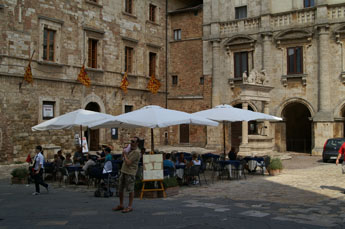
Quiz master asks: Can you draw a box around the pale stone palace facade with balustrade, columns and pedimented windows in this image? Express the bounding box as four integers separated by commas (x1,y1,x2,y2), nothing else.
203,0,345,154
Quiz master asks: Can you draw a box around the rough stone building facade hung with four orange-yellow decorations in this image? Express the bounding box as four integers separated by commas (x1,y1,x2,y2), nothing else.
0,0,166,162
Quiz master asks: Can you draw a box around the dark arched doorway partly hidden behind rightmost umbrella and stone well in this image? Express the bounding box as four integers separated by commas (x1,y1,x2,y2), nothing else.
230,103,257,150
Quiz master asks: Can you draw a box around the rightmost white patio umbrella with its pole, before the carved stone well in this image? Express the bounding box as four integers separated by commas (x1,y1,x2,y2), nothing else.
193,104,283,157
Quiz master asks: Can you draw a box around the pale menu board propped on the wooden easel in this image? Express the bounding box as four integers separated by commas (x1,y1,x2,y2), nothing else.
143,154,164,181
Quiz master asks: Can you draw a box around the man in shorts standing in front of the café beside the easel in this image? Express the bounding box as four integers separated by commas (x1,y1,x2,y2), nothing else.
112,137,140,213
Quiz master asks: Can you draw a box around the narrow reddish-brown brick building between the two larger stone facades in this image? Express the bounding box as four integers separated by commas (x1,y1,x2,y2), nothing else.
168,1,212,146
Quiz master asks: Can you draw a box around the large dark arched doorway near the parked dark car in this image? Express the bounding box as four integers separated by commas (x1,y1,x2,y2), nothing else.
282,102,312,153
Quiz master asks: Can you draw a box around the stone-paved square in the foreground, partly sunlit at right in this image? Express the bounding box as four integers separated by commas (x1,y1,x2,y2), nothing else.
0,155,345,229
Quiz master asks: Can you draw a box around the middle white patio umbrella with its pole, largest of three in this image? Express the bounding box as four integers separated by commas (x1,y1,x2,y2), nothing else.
89,105,218,151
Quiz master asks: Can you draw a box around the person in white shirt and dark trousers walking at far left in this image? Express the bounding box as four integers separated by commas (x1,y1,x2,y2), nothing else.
32,146,48,196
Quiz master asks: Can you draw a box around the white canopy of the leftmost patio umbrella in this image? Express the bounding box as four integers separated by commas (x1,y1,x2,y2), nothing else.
31,109,114,131
